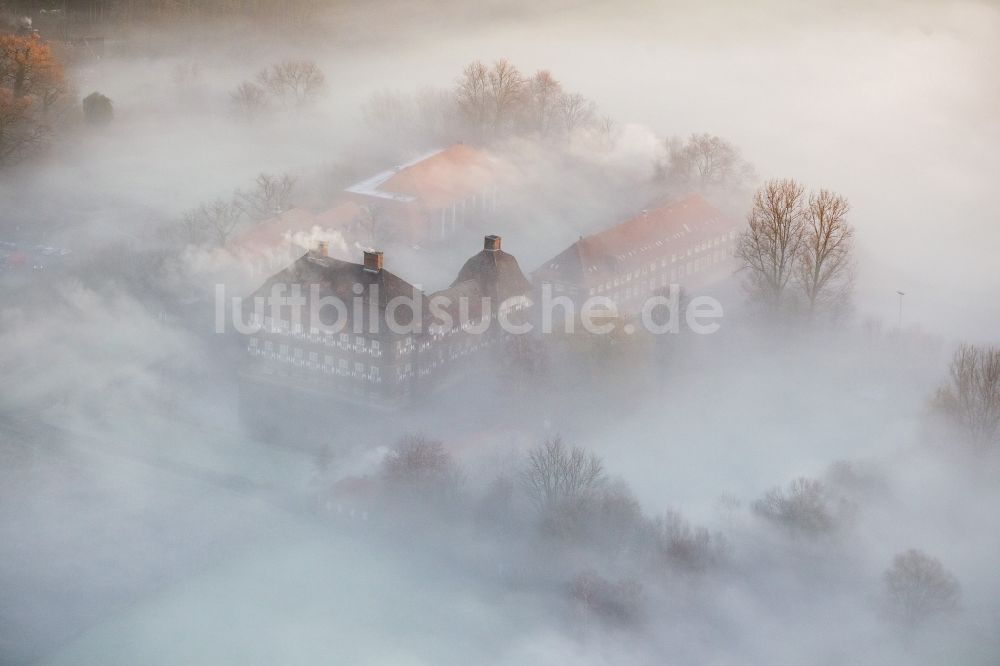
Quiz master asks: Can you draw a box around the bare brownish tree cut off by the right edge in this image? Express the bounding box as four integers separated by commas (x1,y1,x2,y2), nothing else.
934,345,1000,448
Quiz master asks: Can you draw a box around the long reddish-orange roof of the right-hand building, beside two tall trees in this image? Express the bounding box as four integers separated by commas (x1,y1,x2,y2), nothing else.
535,194,734,284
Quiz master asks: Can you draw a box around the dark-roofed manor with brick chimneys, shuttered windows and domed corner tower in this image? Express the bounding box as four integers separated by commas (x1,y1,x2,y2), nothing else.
243,236,531,407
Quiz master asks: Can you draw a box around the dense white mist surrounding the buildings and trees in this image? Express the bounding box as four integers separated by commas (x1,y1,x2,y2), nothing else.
0,1,1000,665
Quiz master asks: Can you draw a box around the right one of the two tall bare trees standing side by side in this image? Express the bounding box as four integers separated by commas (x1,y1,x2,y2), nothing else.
795,190,854,313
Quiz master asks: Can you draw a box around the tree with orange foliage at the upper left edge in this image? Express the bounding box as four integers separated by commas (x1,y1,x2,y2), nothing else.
0,34,66,166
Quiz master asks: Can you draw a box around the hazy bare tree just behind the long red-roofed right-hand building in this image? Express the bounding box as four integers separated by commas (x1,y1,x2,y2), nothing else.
660,134,753,189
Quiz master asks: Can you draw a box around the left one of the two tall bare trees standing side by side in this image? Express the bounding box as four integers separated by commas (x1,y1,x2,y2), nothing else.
736,179,805,307
